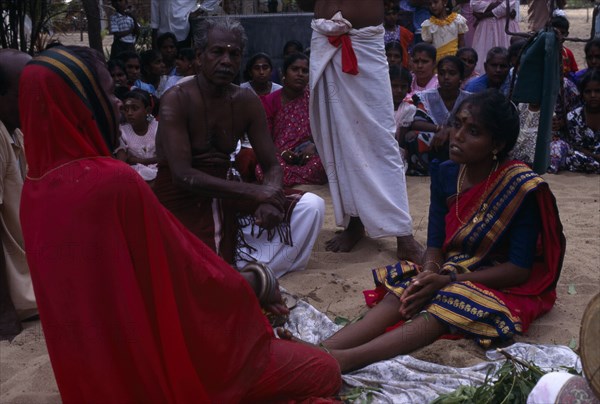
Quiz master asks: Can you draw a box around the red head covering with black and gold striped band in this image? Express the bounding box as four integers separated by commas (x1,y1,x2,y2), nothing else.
19,47,116,178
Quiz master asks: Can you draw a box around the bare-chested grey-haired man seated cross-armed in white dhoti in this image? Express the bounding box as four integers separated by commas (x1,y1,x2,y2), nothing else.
154,18,324,276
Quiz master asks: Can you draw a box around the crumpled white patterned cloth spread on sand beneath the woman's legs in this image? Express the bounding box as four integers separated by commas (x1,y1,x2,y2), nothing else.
285,300,581,404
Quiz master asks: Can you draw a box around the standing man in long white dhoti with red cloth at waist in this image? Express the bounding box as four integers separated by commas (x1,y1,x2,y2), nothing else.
298,0,422,262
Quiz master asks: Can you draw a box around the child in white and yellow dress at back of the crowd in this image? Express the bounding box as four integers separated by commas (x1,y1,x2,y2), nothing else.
421,0,469,60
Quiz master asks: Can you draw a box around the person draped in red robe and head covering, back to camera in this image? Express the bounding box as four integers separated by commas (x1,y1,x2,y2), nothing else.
19,47,341,403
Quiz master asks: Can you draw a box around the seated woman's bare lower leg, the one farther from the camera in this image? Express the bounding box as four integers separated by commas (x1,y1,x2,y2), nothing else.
323,293,402,350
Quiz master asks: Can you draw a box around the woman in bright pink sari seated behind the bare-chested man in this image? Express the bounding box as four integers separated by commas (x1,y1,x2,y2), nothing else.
256,53,327,187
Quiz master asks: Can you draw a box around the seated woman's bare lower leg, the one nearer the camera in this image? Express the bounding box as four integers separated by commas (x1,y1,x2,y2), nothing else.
330,314,448,373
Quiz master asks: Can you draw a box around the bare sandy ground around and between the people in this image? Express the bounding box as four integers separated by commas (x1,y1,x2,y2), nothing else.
0,6,600,404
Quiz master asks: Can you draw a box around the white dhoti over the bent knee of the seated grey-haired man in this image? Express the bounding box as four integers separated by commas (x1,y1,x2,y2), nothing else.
236,192,325,278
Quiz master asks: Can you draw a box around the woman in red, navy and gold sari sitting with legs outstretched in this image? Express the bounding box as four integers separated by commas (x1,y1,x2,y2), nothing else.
322,90,565,372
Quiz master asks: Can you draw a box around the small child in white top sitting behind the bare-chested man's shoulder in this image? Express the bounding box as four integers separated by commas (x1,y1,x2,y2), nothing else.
114,89,158,181
